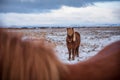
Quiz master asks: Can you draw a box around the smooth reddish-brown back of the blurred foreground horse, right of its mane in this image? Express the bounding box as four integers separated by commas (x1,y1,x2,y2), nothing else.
61,41,120,80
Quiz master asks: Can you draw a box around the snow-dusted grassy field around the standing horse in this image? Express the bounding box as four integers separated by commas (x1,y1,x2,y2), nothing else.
9,27,120,64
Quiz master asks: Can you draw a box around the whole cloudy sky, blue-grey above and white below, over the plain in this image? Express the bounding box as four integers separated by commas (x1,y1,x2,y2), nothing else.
0,0,120,26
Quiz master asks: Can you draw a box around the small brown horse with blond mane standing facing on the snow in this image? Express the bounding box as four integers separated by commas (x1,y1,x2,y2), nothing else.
66,28,80,60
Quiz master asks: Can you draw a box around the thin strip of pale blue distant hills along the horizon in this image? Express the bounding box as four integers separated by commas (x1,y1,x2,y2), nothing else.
0,24,120,29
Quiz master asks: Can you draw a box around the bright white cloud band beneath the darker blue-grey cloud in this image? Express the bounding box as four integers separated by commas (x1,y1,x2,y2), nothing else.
0,2,120,26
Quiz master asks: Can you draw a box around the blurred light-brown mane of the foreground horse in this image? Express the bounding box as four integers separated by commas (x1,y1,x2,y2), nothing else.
0,29,67,80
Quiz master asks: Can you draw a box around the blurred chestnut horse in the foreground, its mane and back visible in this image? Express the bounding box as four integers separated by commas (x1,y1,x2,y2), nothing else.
0,29,120,80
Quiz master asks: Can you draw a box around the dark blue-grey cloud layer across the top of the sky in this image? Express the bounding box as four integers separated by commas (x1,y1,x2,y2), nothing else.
0,0,119,13
